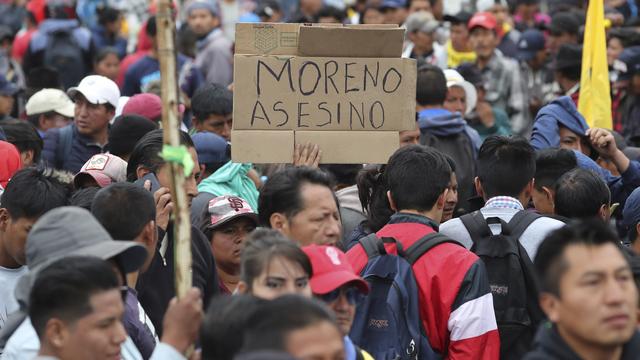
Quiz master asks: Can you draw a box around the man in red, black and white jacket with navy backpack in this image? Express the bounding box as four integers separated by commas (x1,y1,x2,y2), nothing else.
347,145,500,359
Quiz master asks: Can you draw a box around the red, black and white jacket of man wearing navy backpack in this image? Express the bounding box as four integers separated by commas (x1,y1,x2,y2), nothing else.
347,213,500,359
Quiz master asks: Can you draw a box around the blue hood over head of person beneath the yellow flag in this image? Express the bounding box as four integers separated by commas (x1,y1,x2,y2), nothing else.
531,96,589,150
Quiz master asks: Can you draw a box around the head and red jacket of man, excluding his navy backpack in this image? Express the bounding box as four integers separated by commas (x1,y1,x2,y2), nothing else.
347,145,500,359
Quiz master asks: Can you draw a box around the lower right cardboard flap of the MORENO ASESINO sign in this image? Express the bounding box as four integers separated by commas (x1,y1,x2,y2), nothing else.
296,131,400,164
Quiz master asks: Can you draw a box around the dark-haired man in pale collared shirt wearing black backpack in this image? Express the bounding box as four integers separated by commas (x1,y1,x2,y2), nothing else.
440,136,564,359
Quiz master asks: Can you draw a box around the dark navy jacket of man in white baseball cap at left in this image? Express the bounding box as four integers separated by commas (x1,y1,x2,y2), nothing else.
42,124,106,174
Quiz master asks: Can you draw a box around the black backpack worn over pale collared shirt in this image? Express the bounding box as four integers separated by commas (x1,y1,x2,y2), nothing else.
460,211,544,359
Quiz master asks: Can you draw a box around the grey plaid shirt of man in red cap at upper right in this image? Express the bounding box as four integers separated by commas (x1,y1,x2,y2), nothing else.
482,49,527,134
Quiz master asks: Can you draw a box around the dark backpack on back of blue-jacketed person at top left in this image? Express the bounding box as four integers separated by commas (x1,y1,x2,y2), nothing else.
44,29,88,89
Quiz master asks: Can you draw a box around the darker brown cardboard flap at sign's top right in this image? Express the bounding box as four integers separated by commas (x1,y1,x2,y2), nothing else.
298,26,404,58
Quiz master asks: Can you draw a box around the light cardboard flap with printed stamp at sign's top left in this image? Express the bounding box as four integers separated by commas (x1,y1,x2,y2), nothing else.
235,23,300,55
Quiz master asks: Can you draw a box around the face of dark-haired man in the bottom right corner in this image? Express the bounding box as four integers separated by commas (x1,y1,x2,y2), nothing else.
541,244,638,349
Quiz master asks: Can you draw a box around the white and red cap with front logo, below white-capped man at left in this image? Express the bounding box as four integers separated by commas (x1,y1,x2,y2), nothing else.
73,154,127,188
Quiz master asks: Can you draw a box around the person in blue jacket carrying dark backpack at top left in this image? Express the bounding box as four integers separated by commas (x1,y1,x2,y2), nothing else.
22,0,95,89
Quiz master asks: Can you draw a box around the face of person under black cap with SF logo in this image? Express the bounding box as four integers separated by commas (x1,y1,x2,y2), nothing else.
210,217,256,273
